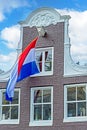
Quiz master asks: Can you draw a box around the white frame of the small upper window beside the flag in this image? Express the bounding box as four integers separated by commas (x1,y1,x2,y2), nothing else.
32,47,54,77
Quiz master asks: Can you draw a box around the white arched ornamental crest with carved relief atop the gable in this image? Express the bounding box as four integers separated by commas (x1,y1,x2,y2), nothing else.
20,7,70,27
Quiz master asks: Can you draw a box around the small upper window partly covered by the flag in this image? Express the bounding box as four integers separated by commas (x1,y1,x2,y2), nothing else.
36,47,53,75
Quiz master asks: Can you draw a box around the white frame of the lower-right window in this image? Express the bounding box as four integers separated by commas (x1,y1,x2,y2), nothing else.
63,83,87,122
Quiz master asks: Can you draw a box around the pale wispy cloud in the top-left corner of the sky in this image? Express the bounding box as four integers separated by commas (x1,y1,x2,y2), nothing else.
0,0,30,22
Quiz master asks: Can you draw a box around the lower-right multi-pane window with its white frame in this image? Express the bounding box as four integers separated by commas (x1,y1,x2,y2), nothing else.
64,84,87,122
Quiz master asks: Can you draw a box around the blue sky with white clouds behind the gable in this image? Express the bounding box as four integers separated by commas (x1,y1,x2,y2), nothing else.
0,0,87,71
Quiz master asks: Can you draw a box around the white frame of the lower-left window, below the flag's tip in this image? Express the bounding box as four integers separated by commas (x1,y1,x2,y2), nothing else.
0,89,20,124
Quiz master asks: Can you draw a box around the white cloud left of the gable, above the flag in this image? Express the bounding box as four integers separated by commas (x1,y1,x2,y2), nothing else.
0,25,20,71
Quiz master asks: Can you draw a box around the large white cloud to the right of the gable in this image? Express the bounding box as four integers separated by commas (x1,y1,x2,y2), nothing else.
58,9,87,65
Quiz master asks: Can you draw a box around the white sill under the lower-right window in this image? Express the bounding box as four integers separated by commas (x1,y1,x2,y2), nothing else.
63,116,87,122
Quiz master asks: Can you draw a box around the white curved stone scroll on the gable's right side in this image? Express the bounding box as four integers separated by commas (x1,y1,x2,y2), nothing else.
64,44,87,77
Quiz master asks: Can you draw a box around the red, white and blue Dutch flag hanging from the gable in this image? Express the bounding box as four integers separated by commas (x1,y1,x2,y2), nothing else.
6,38,39,101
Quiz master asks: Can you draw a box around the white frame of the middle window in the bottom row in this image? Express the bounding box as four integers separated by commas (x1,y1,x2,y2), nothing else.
29,86,53,126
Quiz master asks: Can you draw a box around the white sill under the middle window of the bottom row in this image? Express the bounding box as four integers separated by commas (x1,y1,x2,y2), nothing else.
29,121,53,126
